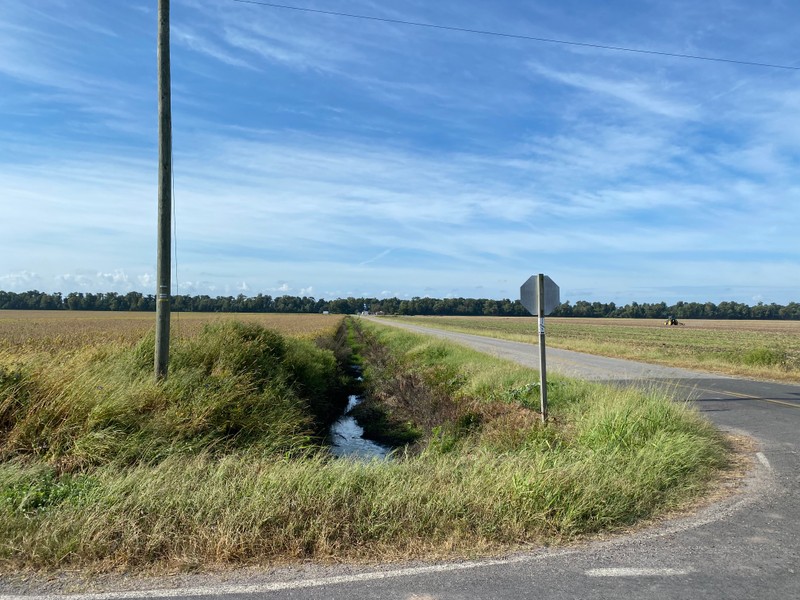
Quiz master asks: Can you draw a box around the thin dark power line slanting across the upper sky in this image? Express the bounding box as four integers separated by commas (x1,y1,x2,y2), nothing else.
232,0,800,71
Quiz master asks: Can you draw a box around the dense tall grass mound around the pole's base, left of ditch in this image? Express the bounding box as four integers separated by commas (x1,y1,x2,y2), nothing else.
0,322,343,471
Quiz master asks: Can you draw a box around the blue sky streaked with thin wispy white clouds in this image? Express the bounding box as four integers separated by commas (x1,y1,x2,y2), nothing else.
0,0,800,304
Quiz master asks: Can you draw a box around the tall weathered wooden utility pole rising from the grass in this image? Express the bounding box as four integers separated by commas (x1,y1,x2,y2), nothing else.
155,0,172,379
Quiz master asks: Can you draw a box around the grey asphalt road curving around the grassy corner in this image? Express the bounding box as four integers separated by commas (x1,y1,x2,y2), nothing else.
0,322,800,600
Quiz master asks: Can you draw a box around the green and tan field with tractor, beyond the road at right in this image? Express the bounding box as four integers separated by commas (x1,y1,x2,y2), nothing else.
390,316,800,381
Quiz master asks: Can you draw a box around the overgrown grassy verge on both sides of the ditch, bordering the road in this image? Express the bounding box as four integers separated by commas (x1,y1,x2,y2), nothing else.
0,324,725,571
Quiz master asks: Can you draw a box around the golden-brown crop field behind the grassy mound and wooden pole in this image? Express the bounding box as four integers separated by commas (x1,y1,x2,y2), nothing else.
0,310,342,351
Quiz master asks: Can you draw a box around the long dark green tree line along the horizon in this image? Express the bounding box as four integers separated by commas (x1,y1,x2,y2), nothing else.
0,290,800,320
